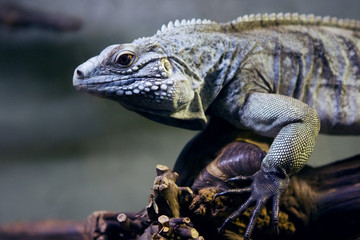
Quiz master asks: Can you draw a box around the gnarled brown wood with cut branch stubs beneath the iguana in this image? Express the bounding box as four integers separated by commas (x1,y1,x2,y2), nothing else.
0,141,360,240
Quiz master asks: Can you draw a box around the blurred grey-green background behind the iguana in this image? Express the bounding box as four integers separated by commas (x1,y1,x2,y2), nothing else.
0,0,360,224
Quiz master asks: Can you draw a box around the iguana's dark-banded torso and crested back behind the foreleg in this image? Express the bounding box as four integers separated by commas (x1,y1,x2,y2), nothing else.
211,19,360,134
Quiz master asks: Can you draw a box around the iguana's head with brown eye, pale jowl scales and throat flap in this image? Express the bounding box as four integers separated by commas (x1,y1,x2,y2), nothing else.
73,34,206,129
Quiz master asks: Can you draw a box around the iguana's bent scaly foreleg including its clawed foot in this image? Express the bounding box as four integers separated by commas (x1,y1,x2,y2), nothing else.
216,93,320,239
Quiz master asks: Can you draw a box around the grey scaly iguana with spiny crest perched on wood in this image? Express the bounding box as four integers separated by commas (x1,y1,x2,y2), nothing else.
73,13,360,239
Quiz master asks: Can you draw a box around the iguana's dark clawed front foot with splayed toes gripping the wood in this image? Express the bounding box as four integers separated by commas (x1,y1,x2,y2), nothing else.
215,169,289,240
